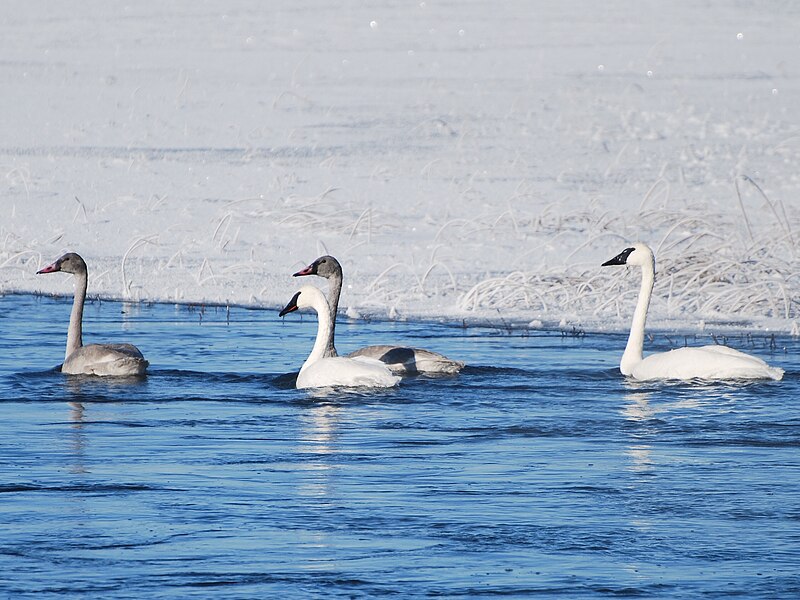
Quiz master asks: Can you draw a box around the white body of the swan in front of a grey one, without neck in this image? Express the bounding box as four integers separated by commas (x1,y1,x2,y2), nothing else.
297,356,400,389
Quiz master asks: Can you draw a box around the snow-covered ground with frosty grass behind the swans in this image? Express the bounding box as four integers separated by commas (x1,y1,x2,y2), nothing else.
0,0,800,332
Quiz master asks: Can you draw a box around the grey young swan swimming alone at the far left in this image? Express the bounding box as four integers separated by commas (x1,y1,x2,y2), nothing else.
36,252,149,375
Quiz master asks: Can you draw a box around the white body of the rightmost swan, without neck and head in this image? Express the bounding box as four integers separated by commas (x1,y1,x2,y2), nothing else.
626,346,783,380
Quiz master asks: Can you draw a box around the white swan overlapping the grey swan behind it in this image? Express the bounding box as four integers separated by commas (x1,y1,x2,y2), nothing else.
279,285,400,389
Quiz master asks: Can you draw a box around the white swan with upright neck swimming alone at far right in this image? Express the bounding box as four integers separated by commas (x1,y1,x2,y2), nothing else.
602,243,783,380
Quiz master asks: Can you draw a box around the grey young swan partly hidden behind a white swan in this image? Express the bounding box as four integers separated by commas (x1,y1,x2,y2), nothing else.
293,255,464,375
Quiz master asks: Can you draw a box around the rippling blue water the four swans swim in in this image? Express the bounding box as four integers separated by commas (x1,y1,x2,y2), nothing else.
0,296,800,598
